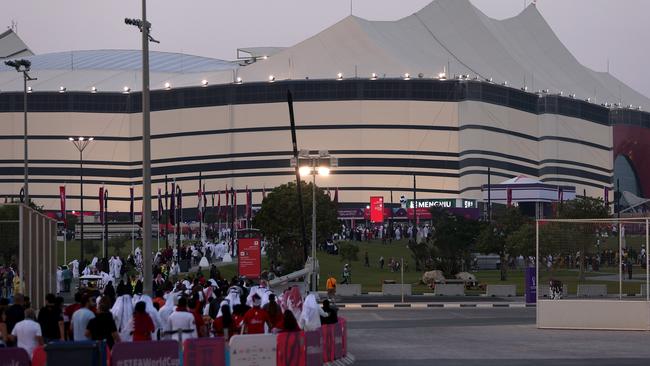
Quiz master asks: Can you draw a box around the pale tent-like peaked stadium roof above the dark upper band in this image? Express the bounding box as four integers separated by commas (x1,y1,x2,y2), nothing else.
0,0,650,109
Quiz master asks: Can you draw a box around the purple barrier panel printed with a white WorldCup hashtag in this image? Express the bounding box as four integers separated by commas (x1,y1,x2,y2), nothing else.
111,341,180,366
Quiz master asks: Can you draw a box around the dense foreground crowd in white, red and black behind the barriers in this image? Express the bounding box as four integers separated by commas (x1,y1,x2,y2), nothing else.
0,260,337,355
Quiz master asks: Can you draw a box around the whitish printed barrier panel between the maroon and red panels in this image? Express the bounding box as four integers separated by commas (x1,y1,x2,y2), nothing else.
230,334,277,366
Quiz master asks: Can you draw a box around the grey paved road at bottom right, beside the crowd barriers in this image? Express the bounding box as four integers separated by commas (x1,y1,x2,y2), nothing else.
340,308,650,366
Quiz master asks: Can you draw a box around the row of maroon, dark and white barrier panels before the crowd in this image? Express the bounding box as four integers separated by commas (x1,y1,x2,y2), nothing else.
0,318,347,366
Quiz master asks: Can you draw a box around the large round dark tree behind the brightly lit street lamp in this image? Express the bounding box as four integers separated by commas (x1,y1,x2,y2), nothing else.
253,182,339,272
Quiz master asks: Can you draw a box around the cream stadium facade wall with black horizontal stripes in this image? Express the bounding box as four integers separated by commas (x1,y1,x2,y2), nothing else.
0,78,628,212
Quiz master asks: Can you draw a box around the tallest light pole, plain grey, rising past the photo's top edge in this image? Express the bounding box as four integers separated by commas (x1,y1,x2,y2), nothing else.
124,0,160,295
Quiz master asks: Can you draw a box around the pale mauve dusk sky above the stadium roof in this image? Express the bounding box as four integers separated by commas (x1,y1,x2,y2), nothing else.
5,0,650,96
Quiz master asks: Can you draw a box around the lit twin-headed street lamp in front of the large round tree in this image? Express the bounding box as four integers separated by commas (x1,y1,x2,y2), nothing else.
291,150,338,291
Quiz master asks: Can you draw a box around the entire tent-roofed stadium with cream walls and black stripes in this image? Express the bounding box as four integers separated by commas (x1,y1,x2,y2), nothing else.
0,0,650,217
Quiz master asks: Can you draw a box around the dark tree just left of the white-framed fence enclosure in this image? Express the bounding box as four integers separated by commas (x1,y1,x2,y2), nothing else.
476,206,535,281
